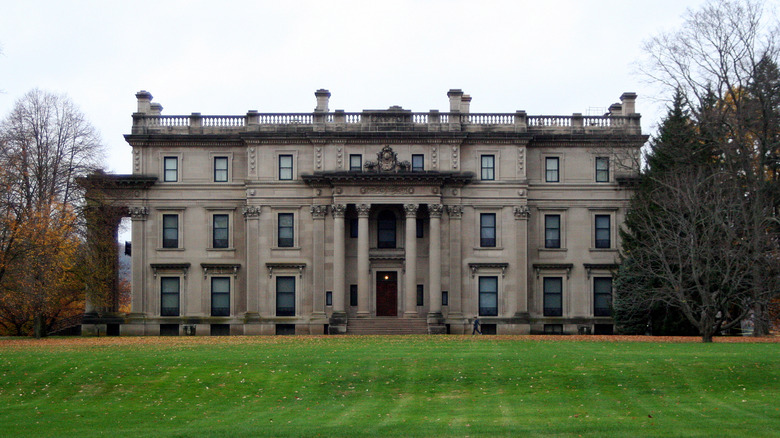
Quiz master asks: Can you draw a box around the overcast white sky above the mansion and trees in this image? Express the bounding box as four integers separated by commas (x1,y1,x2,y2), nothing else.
0,0,774,173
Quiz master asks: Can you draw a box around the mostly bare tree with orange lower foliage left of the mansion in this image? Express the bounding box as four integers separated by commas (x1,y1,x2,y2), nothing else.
0,89,103,333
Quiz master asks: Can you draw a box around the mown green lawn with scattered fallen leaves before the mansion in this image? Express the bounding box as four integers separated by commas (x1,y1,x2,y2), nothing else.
0,336,780,437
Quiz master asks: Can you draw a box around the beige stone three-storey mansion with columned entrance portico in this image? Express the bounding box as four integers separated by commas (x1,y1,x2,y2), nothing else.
109,90,646,335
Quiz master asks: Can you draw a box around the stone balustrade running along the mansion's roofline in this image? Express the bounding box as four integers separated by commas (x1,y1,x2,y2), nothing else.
132,110,641,134
